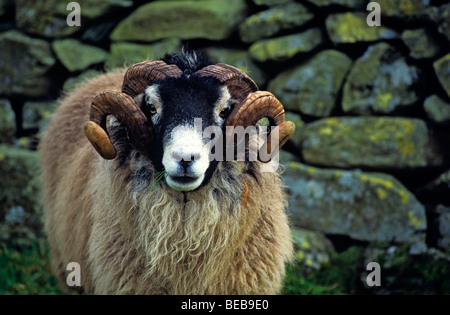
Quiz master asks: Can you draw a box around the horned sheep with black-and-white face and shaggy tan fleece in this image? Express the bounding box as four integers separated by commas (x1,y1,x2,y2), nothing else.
39,53,294,294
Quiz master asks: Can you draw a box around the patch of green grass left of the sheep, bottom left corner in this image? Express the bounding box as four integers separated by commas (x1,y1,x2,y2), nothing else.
0,240,63,294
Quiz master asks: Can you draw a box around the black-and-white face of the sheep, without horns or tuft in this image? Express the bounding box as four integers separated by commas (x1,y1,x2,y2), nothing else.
141,74,233,191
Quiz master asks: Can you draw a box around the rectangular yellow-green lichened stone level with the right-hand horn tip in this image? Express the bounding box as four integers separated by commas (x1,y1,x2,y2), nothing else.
302,117,431,169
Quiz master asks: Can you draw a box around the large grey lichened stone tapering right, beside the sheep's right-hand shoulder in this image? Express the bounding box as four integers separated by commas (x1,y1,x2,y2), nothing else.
284,162,427,243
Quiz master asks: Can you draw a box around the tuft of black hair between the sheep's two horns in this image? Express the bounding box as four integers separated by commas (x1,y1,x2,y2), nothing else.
162,49,214,74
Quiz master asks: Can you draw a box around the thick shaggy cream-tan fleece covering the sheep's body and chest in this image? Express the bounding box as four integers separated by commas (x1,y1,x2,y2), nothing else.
40,70,292,294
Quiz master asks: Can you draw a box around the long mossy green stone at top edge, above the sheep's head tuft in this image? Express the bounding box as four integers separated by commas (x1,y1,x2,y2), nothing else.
111,0,246,41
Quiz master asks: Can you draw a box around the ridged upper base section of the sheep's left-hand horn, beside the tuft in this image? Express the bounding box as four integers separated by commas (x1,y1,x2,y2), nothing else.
122,60,182,97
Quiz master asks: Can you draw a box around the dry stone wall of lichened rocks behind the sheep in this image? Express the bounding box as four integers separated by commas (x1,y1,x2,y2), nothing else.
0,0,450,292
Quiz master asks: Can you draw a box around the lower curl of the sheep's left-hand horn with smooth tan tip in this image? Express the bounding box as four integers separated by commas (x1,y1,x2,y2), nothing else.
84,91,153,159
